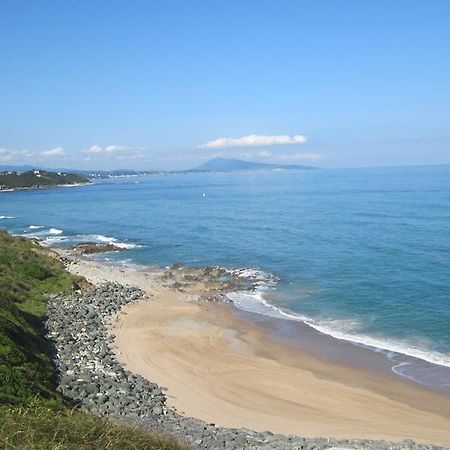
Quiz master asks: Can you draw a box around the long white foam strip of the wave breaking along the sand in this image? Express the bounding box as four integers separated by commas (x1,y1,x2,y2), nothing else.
227,289,450,373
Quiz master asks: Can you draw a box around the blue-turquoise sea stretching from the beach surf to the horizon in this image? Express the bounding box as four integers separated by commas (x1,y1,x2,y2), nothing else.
0,166,450,386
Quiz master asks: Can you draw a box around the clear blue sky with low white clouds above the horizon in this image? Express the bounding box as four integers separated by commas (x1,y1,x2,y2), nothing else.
0,0,450,169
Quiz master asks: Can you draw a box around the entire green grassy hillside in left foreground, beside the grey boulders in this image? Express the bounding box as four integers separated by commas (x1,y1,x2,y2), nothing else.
0,230,184,450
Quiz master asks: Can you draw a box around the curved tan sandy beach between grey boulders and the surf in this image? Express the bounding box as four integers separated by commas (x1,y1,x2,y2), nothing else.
61,252,450,446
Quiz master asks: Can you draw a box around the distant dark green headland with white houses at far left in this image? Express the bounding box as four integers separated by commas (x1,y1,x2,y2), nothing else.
0,170,89,190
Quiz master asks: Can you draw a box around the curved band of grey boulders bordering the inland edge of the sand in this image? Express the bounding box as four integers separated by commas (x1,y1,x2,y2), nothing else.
47,283,446,450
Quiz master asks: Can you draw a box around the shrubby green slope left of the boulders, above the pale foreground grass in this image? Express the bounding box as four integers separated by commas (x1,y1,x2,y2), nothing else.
0,231,80,405
